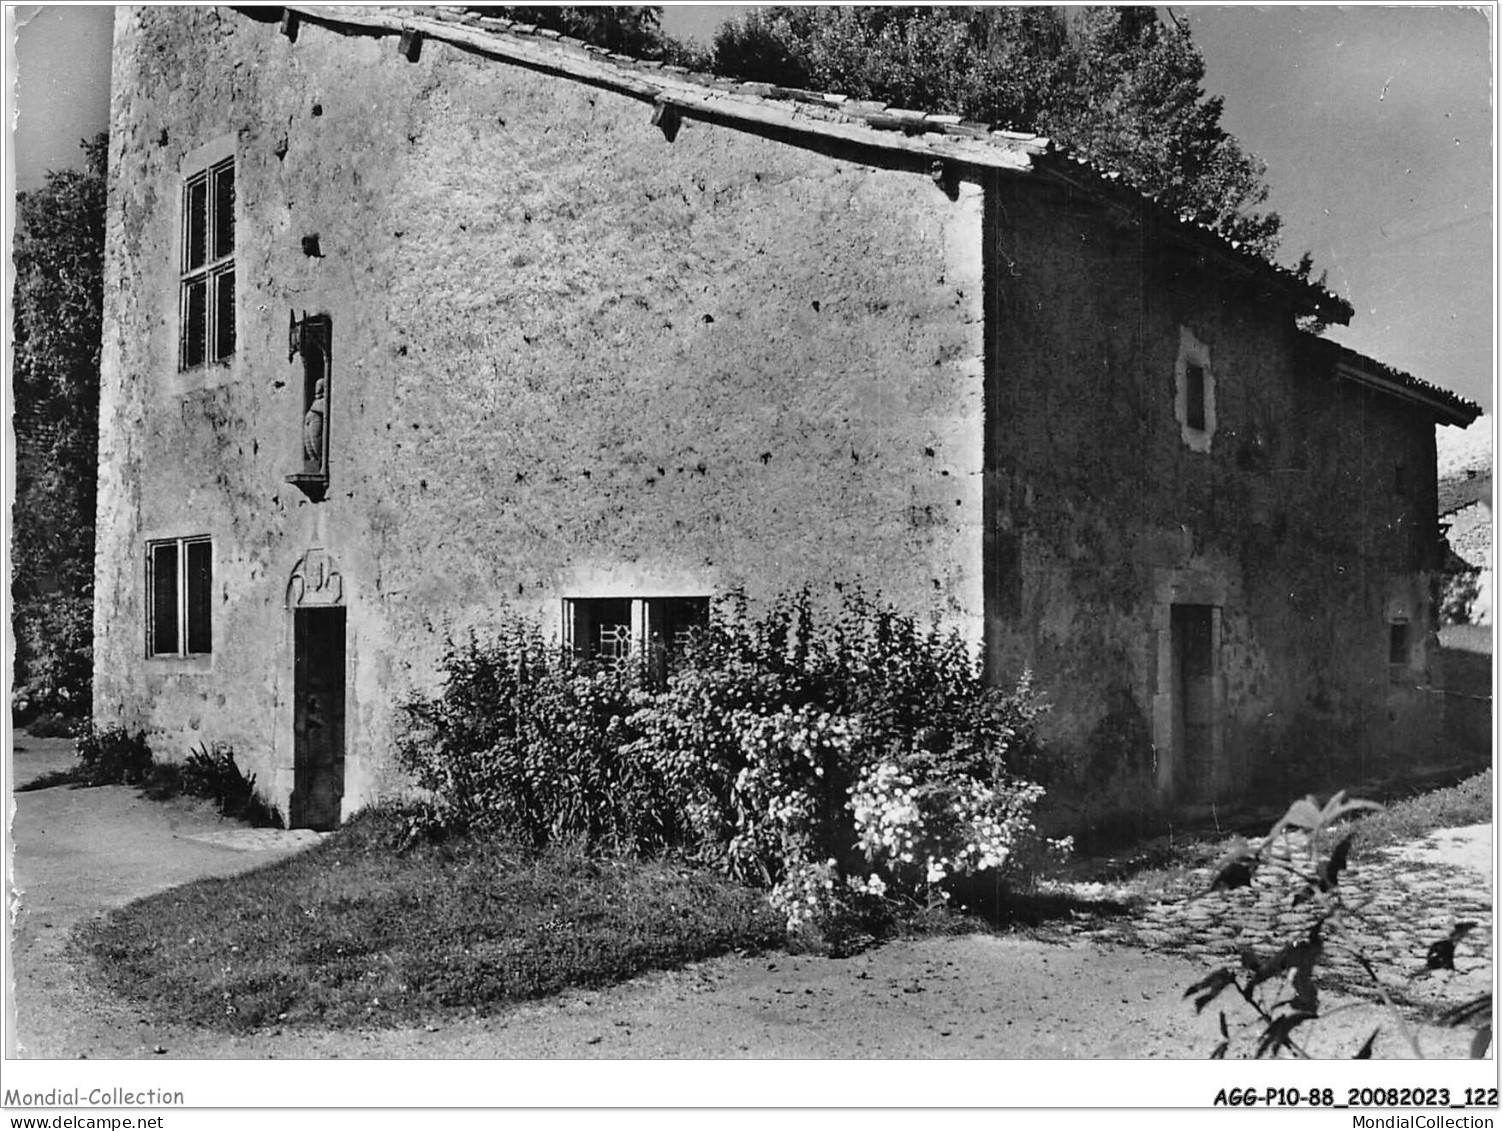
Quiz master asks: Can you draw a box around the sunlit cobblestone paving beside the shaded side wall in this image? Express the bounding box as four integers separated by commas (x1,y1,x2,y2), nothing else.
1060,841,1492,1005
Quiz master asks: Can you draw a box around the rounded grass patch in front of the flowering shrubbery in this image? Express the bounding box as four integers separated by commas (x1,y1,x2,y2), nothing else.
80,811,783,1030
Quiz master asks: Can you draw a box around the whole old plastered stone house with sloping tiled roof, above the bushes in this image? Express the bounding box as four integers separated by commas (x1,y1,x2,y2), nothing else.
95,8,1476,826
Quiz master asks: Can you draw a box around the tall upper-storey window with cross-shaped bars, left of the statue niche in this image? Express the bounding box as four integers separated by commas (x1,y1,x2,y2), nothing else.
177,158,234,368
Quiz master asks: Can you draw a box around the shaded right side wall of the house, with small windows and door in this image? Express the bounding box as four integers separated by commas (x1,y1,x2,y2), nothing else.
984,172,1438,829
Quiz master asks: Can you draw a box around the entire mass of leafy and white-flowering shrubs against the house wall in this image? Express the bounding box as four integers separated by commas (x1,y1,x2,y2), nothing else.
400,590,1049,929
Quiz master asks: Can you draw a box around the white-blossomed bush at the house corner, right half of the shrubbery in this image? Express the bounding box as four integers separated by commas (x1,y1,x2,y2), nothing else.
630,591,1064,929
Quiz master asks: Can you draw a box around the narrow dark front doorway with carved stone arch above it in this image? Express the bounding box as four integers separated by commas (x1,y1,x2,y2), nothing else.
287,549,346,832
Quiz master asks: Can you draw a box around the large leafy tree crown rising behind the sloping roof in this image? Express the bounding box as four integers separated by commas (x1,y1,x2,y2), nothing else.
714,6,1279,254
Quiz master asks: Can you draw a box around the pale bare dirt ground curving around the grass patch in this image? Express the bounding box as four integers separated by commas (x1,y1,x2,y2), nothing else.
6,735,1477,1060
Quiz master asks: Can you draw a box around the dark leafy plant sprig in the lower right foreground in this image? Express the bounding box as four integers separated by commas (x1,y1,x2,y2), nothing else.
1184,791,1492,1060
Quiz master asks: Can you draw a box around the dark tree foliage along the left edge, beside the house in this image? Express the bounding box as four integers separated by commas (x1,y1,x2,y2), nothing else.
11,134,108,710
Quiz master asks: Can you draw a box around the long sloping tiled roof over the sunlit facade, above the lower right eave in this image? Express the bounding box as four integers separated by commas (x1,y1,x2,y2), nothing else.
276,5,1353,323
